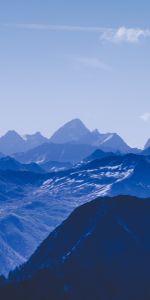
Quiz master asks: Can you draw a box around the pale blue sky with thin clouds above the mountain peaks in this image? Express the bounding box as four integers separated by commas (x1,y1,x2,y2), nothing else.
0,0,150,147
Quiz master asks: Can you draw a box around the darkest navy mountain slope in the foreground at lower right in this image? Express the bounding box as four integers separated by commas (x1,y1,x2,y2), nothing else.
0,196,150,300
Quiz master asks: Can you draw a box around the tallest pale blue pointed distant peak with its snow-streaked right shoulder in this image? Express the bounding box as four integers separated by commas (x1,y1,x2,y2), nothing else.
50,119,139,153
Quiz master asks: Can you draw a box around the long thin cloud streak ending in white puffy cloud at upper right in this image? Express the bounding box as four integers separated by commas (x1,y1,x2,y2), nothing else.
0,23,150,43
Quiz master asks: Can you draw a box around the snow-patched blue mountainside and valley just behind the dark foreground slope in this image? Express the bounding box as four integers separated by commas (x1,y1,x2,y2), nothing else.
0,154,150,275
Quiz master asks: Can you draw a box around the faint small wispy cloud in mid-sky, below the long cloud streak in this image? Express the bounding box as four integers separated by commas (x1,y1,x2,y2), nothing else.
73,57,111,71
